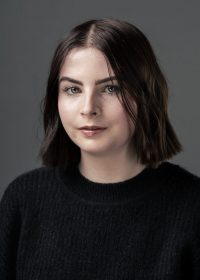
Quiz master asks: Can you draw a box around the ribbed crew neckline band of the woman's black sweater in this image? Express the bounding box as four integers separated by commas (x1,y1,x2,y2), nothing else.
57,162,170,204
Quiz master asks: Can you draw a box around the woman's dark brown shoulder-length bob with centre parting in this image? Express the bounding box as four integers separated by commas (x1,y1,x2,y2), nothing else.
38,18,183,168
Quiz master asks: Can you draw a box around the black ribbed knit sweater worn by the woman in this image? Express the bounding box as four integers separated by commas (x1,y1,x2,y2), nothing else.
0,162,200,280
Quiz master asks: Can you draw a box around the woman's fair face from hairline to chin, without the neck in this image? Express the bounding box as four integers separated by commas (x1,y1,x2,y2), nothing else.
58,48,137,159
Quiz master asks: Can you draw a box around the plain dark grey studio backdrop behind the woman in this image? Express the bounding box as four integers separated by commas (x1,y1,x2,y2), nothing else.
0,0,200,198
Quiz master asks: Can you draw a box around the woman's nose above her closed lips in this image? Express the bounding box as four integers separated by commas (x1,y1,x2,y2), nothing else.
81,94,101,116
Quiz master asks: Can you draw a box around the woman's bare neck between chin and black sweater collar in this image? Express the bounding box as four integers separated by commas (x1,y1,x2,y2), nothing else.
79,150,146,183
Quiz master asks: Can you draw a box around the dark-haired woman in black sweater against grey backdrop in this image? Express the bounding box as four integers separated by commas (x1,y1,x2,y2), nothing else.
0,19,200,280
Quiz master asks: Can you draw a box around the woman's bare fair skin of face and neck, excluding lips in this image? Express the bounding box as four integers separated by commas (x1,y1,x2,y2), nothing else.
58,48,145,183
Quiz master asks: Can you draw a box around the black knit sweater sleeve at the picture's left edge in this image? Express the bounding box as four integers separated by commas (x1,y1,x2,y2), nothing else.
0,182,20,280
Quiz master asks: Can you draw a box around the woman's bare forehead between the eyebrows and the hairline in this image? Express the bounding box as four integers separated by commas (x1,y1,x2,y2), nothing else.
60,47,114,76
